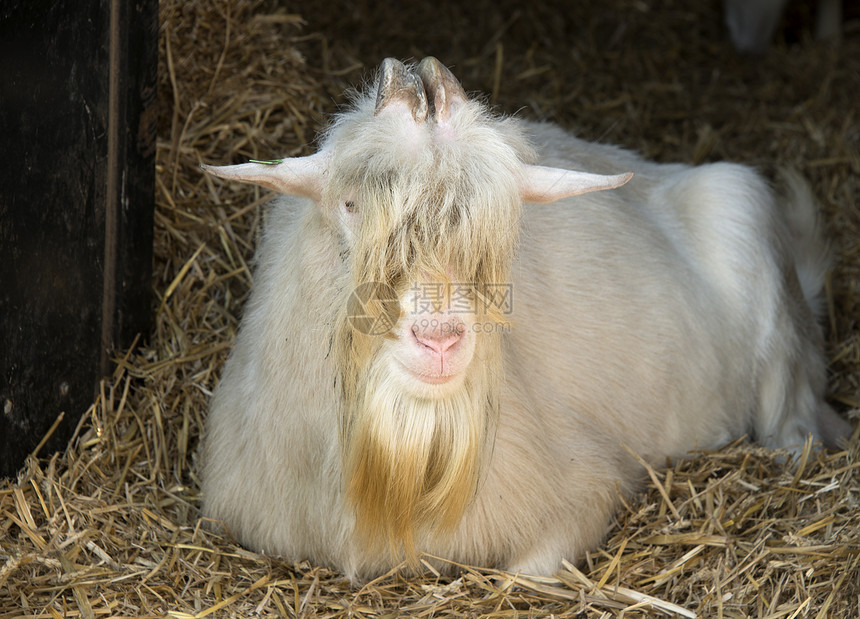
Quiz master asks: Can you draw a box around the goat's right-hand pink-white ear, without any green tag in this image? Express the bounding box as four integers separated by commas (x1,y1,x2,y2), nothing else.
520,165,633,203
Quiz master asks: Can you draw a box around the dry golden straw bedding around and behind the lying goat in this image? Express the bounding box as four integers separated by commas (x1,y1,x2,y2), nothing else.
0,0,860,619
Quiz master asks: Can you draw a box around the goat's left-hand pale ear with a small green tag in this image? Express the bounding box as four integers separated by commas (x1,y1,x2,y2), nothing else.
200,152,328,200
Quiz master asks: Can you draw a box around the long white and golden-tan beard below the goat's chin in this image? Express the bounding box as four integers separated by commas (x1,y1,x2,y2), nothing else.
342,346,499,566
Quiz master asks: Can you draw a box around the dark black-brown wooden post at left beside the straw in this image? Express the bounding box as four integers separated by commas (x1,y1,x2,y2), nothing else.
0,0,158,476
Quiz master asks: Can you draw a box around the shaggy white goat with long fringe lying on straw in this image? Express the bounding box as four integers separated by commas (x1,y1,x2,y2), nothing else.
202,58,850,579
